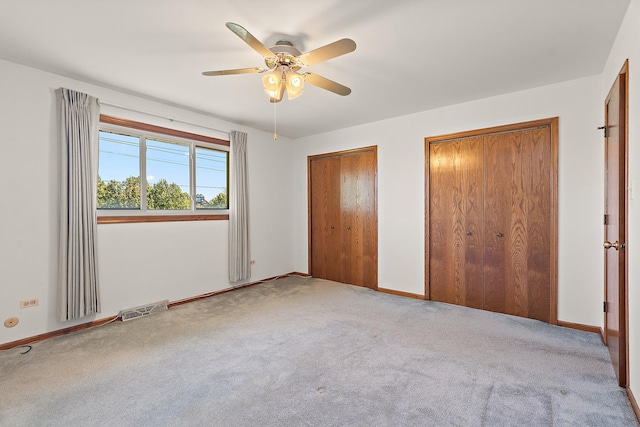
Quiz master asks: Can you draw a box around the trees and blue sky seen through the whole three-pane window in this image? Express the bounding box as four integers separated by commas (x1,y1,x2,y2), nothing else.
97,131,228,211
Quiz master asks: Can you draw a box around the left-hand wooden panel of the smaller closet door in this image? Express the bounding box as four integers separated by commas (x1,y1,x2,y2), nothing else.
309,156,342,281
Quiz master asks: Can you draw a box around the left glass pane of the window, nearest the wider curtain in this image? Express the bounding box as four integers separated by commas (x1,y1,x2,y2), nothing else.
97,132,140,209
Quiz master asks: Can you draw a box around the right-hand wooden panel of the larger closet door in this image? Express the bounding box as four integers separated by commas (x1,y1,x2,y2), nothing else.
484,127,553,322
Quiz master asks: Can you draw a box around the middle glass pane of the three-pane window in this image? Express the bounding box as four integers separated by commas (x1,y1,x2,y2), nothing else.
147,139,191,210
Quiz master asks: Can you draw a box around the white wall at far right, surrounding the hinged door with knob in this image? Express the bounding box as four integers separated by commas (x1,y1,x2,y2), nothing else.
600,0,640,399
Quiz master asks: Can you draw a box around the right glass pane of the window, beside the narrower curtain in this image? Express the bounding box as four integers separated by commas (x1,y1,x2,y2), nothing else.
196,147,229,209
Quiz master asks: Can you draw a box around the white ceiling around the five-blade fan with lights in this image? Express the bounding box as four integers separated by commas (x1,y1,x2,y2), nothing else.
0,0,629,138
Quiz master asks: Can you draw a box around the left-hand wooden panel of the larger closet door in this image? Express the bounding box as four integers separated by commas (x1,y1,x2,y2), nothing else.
429,137,483,308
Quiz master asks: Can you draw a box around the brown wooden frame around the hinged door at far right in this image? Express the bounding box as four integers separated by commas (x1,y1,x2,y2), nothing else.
602,59,629,388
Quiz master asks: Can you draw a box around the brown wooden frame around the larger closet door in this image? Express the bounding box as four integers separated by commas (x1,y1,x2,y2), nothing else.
424,117,558,325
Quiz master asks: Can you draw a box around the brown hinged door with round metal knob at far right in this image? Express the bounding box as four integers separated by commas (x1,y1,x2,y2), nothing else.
604,63,627,387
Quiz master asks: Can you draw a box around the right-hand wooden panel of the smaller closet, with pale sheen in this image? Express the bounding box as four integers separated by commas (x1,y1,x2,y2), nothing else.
340,150,378,289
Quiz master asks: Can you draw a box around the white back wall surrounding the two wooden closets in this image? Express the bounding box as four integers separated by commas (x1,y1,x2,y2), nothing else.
293,76,603,326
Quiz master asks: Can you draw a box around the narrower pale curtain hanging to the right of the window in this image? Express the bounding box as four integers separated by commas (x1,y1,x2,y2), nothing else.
229,130,251,283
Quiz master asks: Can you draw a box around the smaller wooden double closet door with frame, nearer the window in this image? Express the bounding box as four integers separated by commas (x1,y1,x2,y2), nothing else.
308,147,378,289
